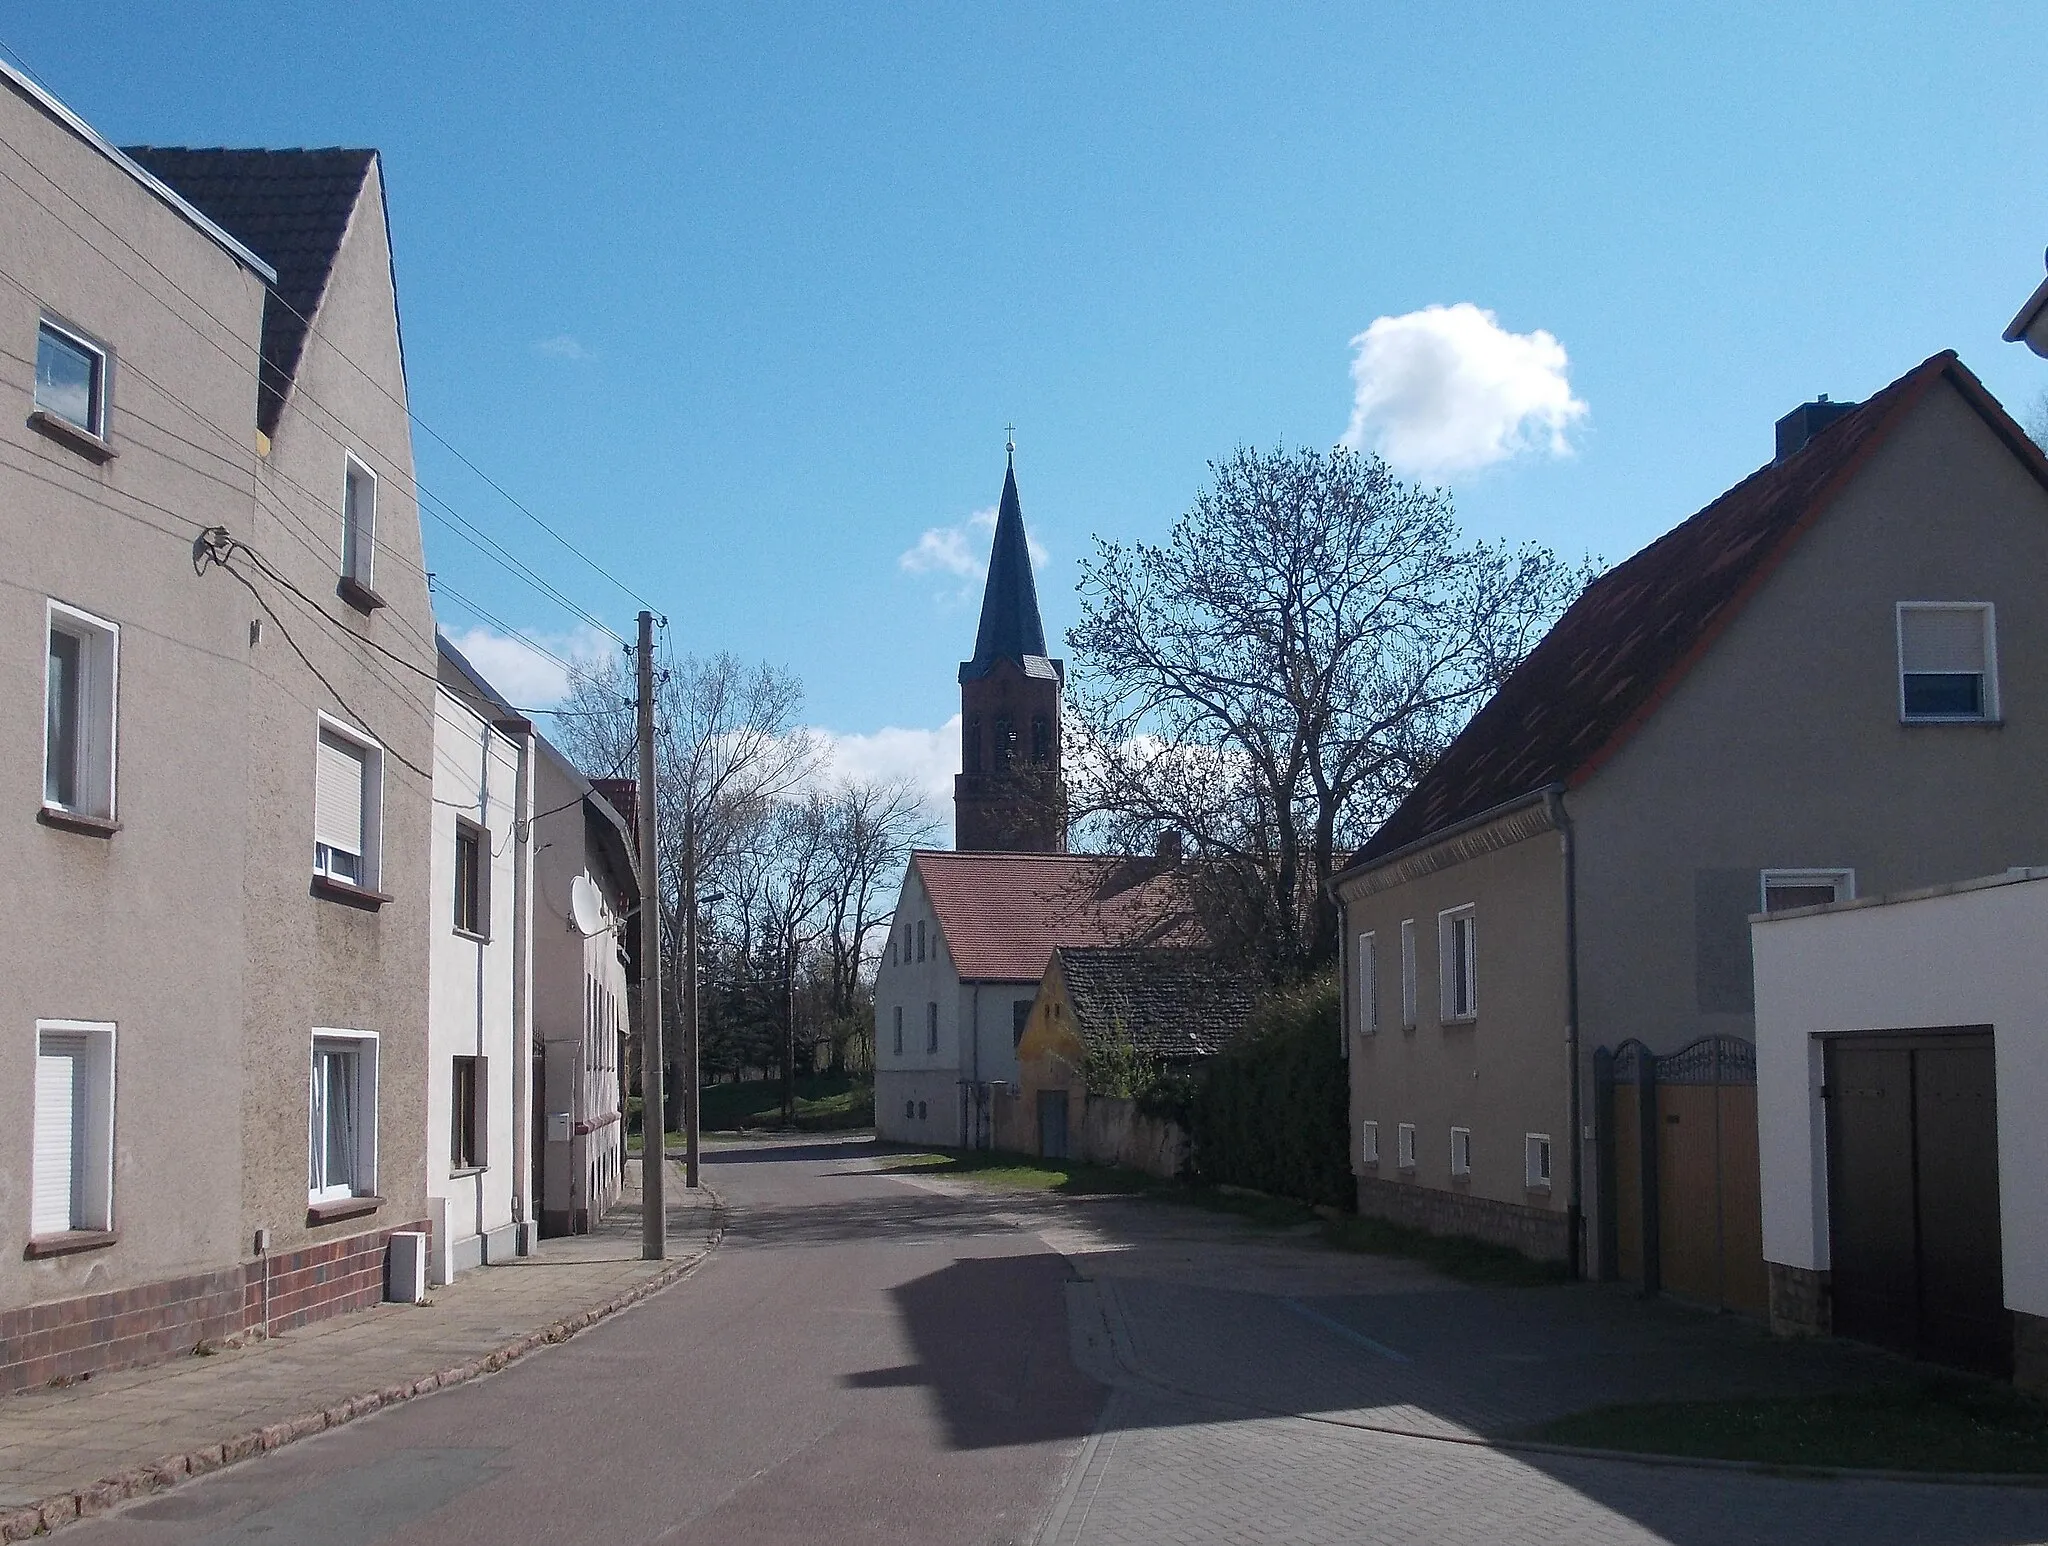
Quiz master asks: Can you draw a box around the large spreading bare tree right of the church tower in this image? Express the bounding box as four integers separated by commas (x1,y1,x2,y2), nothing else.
1067,446,1591,977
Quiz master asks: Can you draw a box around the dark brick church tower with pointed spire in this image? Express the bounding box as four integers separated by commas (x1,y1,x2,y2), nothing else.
952,444,1067,854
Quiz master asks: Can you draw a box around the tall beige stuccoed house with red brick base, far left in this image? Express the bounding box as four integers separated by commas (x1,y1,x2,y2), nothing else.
0,66,434,1388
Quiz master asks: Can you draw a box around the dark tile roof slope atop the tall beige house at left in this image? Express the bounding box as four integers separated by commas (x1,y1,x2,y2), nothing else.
125,145,377,434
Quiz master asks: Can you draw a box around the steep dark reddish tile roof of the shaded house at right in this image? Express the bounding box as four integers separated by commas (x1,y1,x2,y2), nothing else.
1350,350,2048,870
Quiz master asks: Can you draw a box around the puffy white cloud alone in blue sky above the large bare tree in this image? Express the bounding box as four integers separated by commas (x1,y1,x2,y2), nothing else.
1343,301,1587,475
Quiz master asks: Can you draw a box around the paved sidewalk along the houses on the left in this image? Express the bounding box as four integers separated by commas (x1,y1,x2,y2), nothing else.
0,1163,721,1540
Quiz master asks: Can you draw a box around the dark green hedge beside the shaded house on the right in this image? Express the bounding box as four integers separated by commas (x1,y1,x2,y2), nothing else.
1188,973,1358,1210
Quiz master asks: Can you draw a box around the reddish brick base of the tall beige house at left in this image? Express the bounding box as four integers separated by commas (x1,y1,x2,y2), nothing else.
0,1220,426,1394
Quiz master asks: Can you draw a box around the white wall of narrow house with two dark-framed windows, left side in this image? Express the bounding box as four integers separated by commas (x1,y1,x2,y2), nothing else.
426,690,524,1280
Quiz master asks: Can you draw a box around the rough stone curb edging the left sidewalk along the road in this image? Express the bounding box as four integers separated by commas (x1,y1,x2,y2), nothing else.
0,1186,725,1542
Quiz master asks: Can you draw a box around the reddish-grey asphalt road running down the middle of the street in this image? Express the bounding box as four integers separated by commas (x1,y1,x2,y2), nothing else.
63,1141,1106,1546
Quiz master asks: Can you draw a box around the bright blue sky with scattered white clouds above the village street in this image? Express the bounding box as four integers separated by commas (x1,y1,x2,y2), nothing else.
0,0,2048,823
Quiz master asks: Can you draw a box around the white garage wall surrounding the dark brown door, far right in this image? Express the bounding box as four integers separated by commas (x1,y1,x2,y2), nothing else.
1751,870,2048,1315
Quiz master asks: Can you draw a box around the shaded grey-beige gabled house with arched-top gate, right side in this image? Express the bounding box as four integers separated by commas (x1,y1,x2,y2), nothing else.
1333,354,2048,1315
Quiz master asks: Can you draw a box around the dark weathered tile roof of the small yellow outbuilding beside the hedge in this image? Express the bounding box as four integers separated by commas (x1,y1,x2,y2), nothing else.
1053,948,1251,1059
